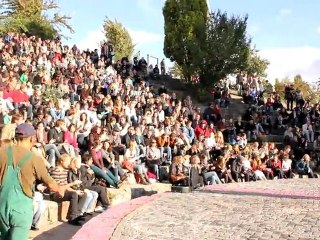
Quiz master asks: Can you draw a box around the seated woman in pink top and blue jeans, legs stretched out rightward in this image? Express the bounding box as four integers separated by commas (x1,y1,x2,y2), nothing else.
90,139,119,188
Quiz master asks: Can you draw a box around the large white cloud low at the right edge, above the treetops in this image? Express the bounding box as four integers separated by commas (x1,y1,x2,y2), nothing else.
259,46,320,83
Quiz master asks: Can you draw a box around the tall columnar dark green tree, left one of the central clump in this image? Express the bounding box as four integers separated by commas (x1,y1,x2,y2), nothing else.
163,0,208,81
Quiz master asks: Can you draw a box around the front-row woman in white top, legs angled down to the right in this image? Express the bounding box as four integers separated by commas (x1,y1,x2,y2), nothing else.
122,140,149,185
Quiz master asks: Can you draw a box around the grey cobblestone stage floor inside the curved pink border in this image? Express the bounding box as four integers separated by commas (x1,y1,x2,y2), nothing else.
112,179,320,240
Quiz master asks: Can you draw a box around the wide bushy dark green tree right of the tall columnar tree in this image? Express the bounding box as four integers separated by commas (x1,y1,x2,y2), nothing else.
199,11,250,87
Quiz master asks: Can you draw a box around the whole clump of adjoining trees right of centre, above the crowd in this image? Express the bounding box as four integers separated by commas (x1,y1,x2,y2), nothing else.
163,0,269,87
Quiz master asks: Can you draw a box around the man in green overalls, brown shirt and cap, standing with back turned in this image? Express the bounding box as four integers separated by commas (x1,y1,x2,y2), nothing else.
0,123,65,240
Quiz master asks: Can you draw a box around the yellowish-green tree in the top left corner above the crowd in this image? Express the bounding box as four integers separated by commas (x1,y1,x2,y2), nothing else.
0,0,74,38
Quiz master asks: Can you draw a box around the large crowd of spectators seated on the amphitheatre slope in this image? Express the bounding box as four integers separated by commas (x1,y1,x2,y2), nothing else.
0,33,320,238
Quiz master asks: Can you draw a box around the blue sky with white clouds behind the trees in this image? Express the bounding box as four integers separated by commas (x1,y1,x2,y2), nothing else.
58,0,320,82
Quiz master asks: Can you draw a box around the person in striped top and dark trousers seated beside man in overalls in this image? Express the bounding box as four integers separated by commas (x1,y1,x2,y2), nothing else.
50,154,82,226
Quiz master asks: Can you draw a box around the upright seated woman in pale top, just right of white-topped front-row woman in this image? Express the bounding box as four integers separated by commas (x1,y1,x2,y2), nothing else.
146,139,161,180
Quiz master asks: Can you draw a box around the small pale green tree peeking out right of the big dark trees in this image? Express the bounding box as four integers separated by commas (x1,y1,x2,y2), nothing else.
244,48,269,77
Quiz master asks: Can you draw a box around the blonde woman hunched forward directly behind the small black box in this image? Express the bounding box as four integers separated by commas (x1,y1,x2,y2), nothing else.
169,156,190,186
